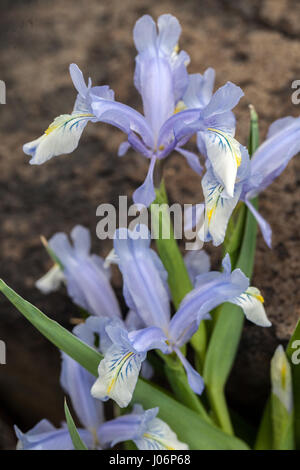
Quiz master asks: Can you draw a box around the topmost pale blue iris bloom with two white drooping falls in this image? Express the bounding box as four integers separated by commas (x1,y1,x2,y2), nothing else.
23,15,243,206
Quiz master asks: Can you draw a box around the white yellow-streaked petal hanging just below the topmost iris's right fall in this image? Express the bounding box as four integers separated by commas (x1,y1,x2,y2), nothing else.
199,170,242,246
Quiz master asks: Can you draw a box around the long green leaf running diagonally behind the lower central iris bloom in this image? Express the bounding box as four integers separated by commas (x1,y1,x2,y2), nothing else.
0,280,248,450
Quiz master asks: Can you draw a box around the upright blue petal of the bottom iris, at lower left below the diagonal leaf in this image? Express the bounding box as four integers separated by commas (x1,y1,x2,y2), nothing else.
60,353,104,433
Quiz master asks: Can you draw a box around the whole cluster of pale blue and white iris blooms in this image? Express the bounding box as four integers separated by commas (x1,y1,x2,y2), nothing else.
16,15,300,449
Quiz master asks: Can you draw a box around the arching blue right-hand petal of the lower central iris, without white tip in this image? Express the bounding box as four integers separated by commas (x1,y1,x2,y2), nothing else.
169,260,249,347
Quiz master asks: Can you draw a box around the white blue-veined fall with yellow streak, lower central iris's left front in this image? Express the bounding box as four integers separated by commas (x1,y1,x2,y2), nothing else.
91,344,146,408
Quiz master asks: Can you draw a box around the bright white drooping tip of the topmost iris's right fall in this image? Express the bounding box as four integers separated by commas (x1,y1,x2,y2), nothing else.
204,128,242,197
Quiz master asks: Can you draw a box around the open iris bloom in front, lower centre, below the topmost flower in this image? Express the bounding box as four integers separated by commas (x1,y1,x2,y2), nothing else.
92,226,270,406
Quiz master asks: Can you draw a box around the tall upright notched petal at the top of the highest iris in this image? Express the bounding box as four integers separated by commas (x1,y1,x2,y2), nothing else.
133,15,188,143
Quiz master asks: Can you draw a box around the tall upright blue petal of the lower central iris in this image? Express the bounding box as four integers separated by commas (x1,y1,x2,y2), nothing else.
114,225,170,331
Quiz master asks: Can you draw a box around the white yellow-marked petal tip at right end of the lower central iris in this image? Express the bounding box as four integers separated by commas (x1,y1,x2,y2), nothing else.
234,287,271,326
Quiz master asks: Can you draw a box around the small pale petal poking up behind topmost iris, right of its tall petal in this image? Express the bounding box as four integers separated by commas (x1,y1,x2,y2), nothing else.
182,68,215,109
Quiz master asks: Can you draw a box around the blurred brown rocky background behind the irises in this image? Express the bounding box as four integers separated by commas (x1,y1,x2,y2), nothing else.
0,0,300,448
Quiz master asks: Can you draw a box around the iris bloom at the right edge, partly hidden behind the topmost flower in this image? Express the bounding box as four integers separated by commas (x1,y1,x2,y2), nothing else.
186,117,300,248
